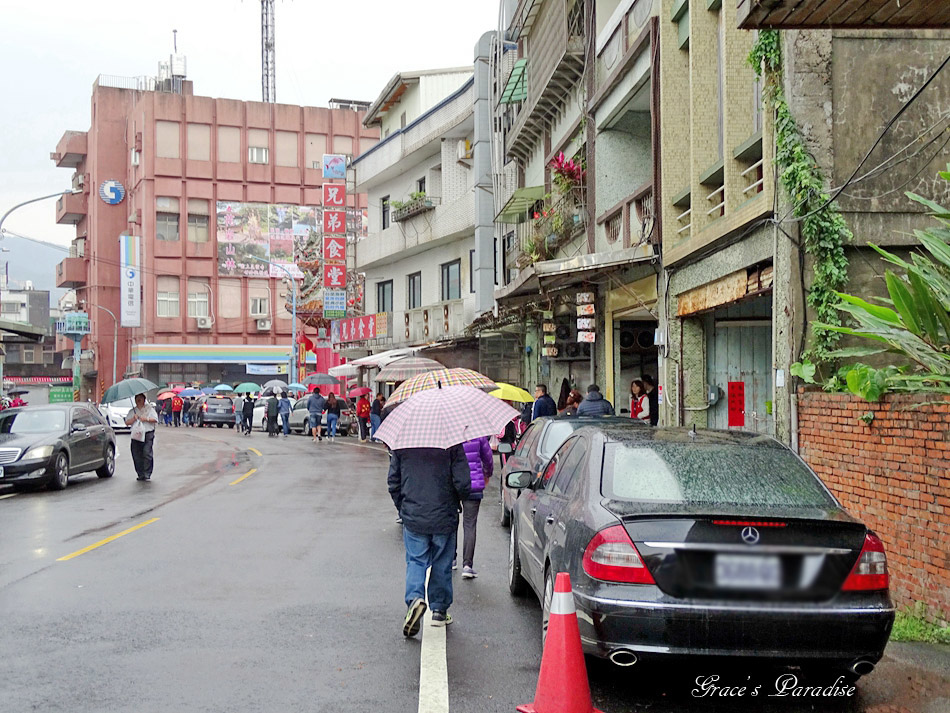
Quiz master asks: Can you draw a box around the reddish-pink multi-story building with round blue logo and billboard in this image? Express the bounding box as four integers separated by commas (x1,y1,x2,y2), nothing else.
51,56,378,399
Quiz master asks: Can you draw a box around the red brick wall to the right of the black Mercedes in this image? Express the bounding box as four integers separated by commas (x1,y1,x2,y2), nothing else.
798,391,950,620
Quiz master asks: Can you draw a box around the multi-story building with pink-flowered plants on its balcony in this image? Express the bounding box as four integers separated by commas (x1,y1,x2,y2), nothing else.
483,0,661,411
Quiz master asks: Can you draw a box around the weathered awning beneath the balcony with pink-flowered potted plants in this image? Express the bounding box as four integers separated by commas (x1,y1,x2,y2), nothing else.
495,244,655,302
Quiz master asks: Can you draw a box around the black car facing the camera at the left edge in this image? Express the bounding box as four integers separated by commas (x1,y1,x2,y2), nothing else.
0,403,115,490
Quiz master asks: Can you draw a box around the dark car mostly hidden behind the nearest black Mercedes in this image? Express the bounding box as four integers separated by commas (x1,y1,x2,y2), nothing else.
498,416,645,527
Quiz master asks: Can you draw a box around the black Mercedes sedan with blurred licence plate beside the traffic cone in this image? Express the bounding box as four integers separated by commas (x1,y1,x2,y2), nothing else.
506,426,894,678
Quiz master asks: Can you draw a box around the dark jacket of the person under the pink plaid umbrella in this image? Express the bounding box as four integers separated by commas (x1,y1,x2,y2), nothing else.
388,444,472,535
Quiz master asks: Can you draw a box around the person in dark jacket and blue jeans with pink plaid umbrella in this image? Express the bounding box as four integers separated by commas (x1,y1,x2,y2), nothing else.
376,386,518,637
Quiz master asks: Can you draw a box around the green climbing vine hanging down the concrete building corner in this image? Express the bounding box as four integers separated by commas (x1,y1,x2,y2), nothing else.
749,30,852,363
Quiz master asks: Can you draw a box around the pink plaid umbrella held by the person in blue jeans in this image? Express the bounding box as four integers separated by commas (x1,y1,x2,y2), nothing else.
376,386,518,450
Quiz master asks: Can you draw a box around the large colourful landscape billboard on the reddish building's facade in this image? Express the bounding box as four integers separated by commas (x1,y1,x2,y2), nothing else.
217,201,321,278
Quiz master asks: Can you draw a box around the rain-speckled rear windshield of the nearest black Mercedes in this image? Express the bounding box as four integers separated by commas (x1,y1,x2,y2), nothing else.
602,443,835,510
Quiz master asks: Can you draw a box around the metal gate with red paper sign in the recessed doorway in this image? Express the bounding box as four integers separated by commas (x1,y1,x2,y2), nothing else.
706,295,775,434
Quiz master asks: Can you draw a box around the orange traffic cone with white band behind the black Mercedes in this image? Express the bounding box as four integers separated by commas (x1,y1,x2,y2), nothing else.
517,572,601,713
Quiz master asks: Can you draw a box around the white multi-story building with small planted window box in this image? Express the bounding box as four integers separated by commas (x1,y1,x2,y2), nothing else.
353,67,497,368
